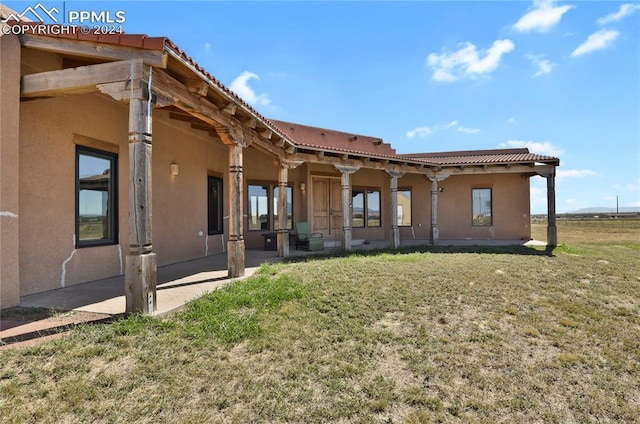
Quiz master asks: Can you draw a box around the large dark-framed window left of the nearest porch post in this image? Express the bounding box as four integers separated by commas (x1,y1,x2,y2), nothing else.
76,146,118,247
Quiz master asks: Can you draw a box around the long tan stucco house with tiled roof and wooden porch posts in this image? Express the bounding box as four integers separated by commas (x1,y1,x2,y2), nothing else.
0,24,559,312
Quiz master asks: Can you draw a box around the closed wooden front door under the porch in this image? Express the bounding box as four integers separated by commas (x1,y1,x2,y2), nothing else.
313,177,342,235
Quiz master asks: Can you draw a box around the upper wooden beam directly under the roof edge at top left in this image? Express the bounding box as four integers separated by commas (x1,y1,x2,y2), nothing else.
18,34,168,68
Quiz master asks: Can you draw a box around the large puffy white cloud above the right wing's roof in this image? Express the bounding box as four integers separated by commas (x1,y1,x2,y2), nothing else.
427,40,515,82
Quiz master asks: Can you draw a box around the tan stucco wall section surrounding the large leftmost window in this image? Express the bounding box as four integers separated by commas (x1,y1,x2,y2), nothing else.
20,95,128,296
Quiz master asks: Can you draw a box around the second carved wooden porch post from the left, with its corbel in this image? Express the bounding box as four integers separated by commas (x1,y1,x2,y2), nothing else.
216,128,247,278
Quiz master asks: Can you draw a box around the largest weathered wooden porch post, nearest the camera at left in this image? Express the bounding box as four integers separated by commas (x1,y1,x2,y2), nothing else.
125,71,158,314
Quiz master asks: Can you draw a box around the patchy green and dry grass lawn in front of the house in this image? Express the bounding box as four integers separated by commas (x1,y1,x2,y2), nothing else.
0,226,640,423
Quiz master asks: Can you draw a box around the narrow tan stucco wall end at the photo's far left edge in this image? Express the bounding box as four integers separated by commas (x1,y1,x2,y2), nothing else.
0,35,21,308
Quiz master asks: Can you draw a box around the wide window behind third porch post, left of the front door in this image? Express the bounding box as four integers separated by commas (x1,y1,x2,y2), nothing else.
247,183,293,231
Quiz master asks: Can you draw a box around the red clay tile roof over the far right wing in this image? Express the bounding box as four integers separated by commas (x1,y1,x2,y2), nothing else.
401,148,559,165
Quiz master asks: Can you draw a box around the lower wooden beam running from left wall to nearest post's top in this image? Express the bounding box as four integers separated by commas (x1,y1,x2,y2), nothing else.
20,60,145,98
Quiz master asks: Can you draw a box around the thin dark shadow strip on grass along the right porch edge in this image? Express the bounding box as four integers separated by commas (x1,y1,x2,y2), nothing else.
283,245,555,263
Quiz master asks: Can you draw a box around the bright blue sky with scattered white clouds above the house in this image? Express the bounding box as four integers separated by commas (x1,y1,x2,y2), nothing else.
4,0,640,214
